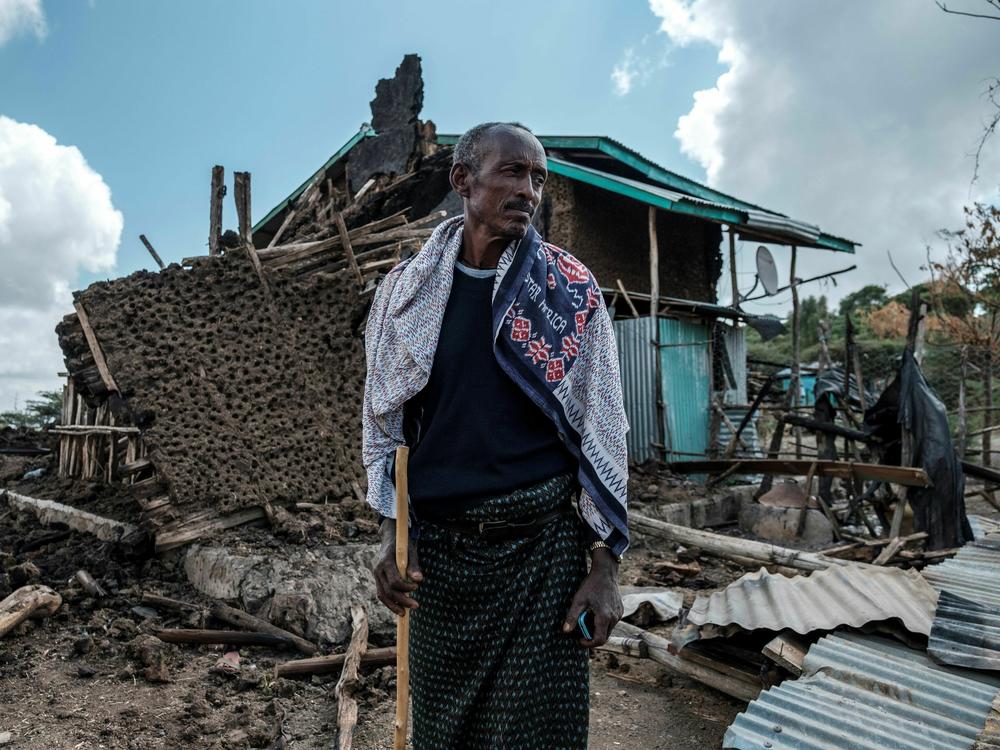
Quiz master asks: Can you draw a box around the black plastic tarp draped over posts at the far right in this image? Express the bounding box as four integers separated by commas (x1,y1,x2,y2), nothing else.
865,351,972,549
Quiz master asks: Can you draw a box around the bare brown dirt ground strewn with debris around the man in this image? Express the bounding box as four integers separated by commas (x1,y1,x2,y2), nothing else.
0,459,744,750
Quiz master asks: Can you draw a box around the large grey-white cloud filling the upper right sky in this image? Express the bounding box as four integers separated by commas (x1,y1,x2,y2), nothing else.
650,0,1000,308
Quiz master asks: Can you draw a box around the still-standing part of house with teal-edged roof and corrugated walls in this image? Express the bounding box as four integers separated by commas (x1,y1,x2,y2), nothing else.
254,125,857,462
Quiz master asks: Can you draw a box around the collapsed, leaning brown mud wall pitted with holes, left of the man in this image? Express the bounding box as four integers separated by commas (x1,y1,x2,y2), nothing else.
78,252,367,513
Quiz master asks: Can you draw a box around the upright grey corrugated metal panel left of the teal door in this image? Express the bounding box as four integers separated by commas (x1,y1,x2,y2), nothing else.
613,317,658,463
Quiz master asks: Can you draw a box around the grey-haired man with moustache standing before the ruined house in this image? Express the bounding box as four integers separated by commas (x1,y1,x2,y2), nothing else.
363,123,628,750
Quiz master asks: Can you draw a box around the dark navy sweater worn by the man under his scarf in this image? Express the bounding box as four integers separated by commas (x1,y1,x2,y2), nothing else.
404,264,577,519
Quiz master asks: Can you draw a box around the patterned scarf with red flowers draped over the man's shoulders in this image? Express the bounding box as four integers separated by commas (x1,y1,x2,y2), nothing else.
362,216,628,555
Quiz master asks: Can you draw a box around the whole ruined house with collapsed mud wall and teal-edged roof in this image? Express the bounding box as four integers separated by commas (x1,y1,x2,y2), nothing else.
53,56,854,550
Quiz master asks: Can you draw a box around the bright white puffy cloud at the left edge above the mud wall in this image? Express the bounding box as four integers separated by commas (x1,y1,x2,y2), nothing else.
0,115,123,410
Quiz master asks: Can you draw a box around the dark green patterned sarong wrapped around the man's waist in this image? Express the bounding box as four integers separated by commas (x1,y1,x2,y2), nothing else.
410,476,589,750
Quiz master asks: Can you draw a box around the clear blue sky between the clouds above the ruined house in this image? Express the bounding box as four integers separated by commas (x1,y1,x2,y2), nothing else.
0,0,721,285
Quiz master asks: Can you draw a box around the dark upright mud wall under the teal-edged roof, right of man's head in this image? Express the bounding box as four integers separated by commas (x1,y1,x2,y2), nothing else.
536,174,722,302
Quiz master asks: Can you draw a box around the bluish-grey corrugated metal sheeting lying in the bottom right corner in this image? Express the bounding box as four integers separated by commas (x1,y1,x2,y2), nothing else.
722,633,1000,750
